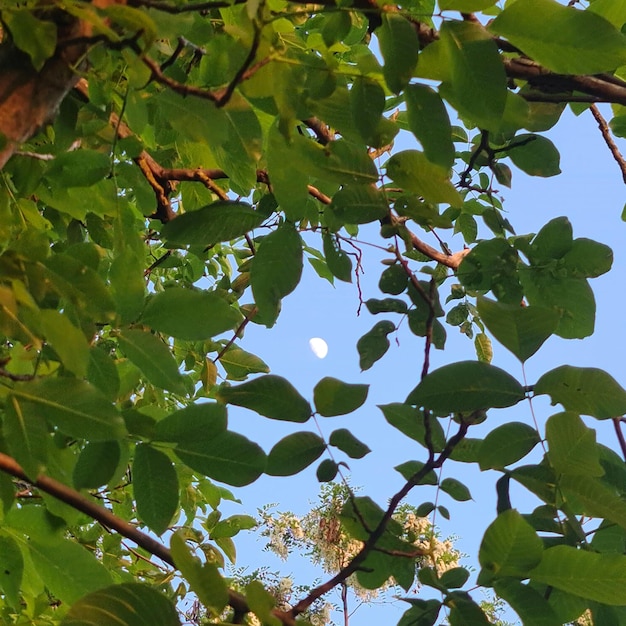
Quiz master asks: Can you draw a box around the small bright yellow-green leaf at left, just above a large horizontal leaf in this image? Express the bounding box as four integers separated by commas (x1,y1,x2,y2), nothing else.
39,309,89,378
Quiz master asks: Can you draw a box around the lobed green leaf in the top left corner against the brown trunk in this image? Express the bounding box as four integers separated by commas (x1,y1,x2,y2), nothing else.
2,10,57,71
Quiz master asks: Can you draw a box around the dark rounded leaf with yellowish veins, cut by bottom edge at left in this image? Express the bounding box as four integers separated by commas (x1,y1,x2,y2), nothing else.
61,583,180,626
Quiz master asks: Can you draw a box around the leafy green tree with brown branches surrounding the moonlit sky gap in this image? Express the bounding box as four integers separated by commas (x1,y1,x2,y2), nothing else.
0,0,626,626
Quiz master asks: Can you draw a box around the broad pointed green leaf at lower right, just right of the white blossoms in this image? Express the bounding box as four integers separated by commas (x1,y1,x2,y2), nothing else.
478,509,543,584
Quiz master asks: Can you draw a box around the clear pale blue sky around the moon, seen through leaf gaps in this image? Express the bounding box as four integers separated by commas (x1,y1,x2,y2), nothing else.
216,105,626,626
